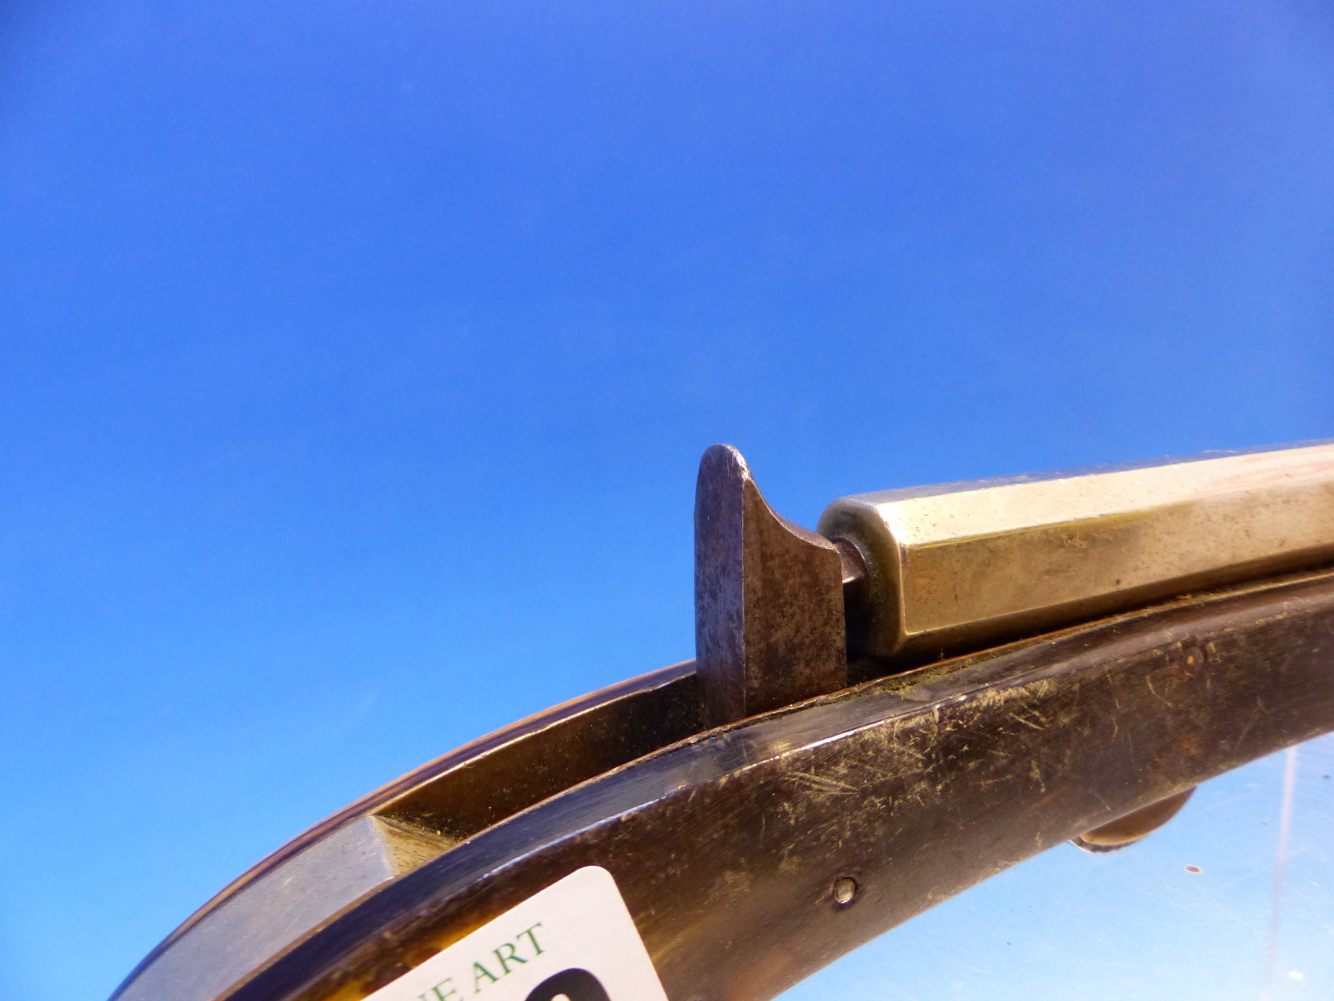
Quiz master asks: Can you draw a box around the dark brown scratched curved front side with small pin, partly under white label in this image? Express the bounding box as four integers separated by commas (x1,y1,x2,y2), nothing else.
112,573,1334,1001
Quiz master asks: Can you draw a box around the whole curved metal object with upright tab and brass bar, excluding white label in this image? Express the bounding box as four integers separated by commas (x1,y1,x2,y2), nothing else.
116,444,1334,1001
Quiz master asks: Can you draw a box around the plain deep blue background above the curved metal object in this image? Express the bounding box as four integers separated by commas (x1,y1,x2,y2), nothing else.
0,0,1334,1001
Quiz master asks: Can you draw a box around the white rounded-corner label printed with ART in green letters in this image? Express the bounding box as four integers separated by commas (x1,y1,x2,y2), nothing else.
366,866,667,1001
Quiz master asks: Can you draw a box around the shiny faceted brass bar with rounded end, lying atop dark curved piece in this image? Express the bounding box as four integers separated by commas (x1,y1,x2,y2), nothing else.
819,442,1334,663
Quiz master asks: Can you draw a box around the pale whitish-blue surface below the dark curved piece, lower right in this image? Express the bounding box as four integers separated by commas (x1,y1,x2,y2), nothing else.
782,735,1334,1001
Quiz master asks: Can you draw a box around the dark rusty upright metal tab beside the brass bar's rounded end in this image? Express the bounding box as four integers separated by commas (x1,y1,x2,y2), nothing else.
695,444,847,726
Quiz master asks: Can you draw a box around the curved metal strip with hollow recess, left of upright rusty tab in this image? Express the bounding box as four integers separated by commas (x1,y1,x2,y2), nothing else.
115,661,703,1001
